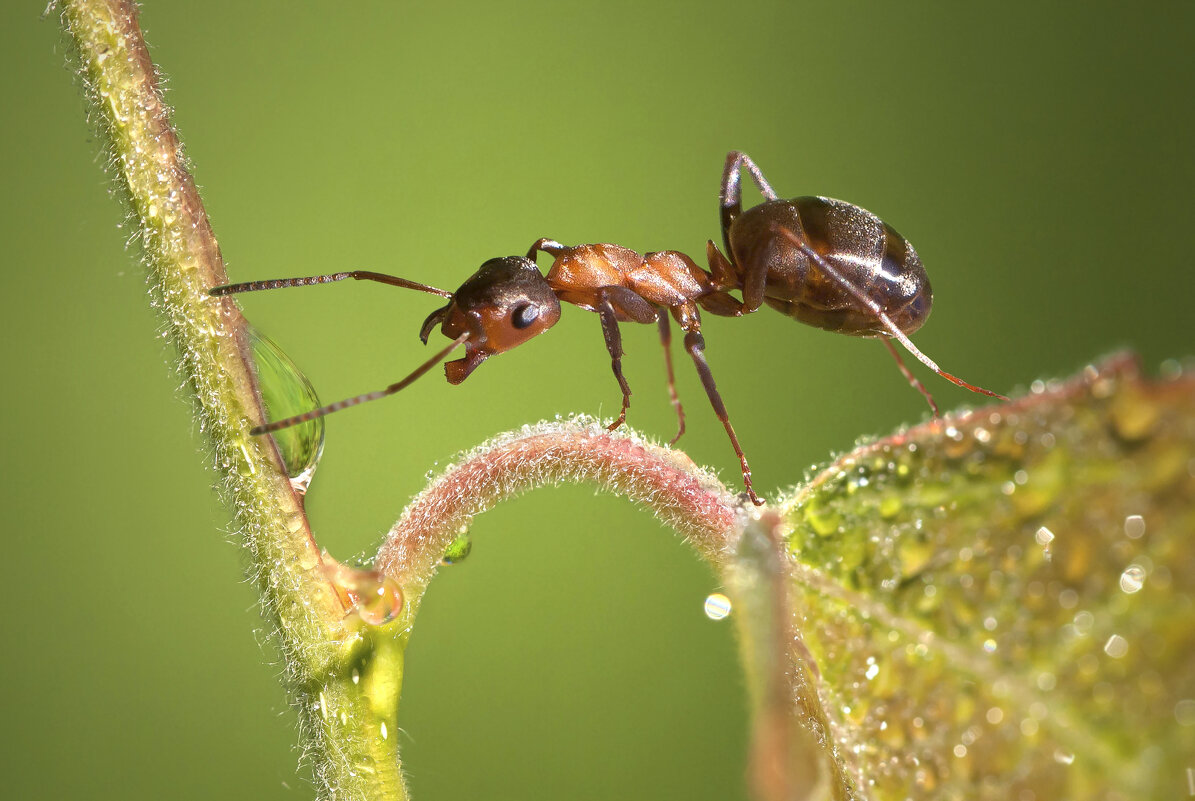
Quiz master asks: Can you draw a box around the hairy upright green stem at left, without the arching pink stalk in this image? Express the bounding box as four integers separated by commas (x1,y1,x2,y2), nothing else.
62,0,405,799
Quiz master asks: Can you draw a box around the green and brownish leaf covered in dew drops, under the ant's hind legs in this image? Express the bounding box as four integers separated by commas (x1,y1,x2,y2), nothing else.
764,357,1195,801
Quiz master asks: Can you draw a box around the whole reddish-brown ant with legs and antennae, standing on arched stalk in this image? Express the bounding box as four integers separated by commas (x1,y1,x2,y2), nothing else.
210,151,1007,505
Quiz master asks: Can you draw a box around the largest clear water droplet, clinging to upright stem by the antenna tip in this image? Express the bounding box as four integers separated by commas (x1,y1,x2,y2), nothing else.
249,326,324,495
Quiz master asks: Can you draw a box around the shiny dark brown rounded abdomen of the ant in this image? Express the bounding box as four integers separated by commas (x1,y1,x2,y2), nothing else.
728,197,933,337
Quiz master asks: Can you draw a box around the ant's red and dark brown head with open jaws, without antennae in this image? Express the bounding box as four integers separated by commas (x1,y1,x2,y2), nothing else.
419,256,560,384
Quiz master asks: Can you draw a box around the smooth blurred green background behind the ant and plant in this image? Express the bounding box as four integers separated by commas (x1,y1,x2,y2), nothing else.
0,0,1195,799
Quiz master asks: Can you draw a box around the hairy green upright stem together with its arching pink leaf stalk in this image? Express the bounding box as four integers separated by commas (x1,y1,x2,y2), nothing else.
62,9,736,800
